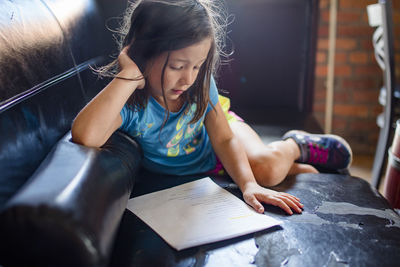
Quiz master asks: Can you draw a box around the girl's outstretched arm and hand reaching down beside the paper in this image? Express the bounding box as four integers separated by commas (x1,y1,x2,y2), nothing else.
205,102,302,214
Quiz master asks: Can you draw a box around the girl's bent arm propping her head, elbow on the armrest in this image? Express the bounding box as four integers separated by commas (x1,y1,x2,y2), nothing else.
71,47,145,147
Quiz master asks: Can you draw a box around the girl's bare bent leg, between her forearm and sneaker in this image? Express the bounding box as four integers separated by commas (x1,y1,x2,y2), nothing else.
230,122,318,186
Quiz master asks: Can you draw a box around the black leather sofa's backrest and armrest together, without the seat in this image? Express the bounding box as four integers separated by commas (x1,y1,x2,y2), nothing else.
0,0,140,266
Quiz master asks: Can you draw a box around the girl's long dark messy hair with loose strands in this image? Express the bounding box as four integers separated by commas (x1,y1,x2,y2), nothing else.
98,0,227,124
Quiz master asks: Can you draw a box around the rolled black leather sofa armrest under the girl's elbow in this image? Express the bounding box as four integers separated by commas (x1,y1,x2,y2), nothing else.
0,132,141,266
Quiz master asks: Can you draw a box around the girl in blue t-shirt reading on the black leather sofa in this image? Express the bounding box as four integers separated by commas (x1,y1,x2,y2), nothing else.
72,0,351,214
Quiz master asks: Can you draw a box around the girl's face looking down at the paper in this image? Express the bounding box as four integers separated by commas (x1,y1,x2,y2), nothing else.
147,38,211,111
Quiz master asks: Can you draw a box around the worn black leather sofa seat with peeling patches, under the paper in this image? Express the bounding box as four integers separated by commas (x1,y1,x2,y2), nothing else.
110,173,400,266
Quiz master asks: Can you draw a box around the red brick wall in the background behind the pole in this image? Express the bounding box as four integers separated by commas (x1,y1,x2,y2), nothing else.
313,0,400,155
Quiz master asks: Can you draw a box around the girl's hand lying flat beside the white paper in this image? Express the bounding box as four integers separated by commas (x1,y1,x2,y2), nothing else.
243,182,303,215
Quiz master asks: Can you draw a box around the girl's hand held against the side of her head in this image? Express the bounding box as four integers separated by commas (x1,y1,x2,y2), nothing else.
117,46,145,89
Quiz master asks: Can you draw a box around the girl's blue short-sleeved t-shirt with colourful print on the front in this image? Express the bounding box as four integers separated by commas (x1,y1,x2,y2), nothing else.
120,78,218,175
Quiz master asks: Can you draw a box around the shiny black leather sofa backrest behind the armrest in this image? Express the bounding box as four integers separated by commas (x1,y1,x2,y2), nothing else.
0,0,126,209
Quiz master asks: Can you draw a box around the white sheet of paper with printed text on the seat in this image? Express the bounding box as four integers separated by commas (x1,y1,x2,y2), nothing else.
127,177,281,250
